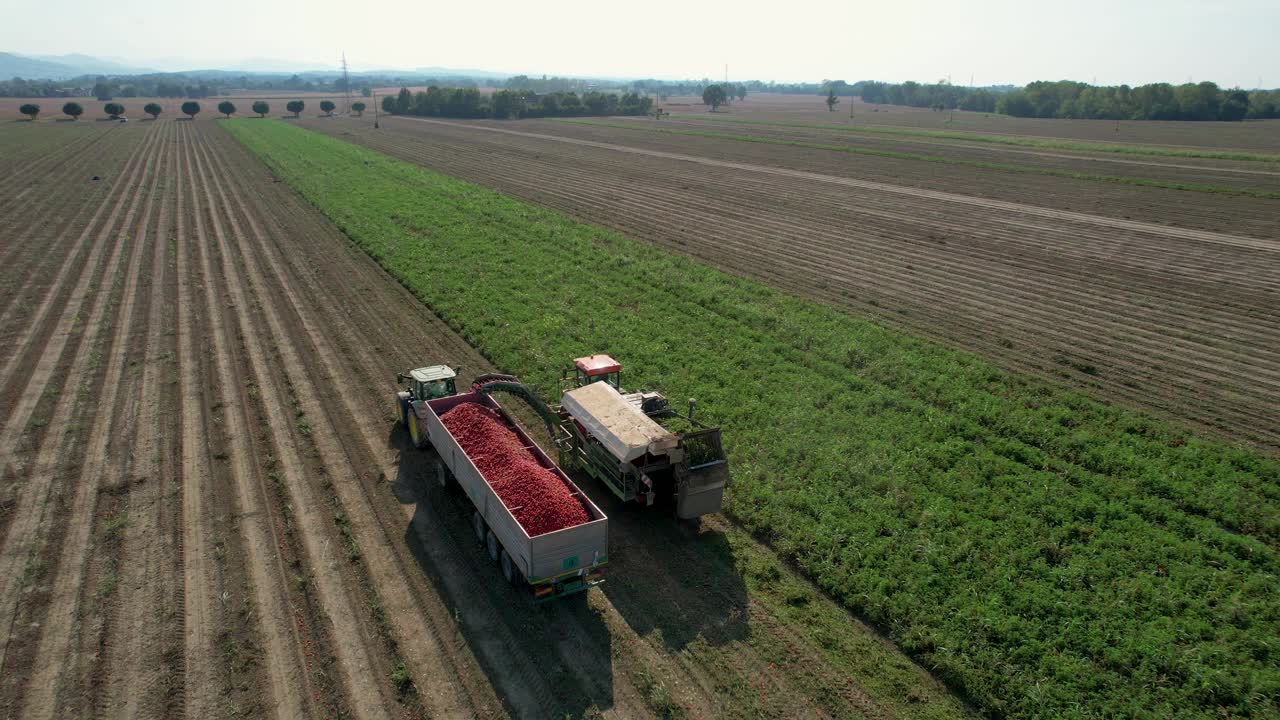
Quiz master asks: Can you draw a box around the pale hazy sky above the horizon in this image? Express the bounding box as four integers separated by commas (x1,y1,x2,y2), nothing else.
0,0,1280,87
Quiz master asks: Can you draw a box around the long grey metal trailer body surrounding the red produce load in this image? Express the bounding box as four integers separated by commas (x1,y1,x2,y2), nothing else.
407,391,609,602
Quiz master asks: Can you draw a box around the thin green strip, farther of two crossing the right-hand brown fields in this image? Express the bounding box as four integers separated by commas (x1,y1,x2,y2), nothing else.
671,113,1280,163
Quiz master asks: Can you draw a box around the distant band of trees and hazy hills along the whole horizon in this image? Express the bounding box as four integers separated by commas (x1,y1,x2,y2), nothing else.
10,70,1280,120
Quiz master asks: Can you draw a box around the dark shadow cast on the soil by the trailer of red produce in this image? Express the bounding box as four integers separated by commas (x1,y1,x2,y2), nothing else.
387,423,613,717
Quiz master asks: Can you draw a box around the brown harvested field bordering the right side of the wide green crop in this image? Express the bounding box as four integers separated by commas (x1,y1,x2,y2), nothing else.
290,118,1280,451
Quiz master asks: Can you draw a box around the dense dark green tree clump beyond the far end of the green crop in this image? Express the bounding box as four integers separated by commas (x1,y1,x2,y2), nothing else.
383,86,653,119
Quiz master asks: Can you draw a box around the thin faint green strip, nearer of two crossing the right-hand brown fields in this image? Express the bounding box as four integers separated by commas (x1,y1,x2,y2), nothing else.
556,118,1280,200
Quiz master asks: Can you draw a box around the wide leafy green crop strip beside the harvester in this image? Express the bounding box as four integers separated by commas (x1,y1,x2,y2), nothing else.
221,119,1280,717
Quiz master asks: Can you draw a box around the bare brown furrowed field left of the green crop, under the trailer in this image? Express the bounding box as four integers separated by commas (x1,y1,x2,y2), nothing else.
0,120,963,717
